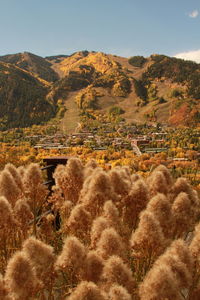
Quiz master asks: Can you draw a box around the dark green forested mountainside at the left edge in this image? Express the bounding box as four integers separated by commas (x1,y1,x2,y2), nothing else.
0,62,55,130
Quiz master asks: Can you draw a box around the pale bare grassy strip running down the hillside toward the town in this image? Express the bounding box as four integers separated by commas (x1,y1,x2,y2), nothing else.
61,92,80,134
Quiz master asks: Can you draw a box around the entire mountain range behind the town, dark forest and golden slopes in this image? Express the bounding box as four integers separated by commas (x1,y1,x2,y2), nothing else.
0,51,200,128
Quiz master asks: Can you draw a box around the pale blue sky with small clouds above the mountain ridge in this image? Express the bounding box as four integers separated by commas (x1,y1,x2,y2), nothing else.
0,0,200,63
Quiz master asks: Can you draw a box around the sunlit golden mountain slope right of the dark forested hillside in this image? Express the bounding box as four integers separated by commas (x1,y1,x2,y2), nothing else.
48,51,200,125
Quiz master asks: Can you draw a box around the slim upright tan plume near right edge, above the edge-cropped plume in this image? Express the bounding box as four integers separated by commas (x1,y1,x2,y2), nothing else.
172,192,192,238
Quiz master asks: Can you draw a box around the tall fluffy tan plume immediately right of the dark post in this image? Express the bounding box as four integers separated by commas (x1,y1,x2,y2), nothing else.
53,158,84,203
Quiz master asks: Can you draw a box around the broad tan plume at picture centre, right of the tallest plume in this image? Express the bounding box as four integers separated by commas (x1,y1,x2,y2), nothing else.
81,170,117,217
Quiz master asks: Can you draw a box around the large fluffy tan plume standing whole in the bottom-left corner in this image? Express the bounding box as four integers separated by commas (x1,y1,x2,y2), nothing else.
5,251,41,300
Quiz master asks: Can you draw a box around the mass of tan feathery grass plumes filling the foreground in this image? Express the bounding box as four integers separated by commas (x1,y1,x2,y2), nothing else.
0,158,200,300
